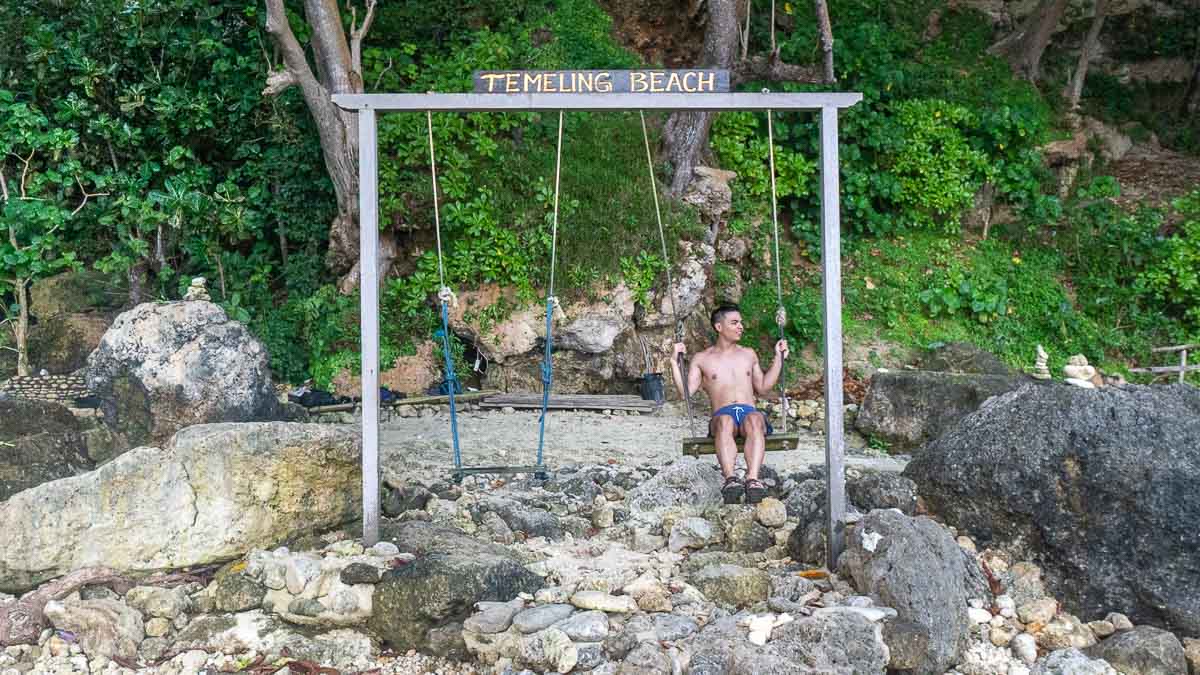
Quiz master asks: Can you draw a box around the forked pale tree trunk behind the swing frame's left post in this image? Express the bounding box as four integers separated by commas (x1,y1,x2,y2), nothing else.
263,0,391,289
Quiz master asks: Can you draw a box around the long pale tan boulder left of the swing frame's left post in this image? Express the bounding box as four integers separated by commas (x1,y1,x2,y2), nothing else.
0,422,361,593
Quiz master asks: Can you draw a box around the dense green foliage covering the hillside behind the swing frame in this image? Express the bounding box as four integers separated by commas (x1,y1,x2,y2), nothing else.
0,0,1200,387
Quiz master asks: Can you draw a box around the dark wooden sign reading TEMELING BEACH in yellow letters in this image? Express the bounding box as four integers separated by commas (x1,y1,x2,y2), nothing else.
474,70,730,94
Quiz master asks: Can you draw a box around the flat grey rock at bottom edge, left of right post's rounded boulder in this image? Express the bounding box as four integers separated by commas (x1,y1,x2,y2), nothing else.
688,611,888,675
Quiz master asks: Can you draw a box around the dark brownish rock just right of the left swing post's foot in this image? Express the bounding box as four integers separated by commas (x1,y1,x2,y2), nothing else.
368,521,541,650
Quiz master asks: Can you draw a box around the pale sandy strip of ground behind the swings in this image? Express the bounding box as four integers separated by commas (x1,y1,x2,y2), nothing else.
379,398,906,477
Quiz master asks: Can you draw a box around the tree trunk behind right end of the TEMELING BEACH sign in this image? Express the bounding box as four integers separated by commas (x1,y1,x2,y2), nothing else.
664,0,738,197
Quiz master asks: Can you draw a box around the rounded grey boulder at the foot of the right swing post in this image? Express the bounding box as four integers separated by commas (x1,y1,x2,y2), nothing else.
838,509,983,675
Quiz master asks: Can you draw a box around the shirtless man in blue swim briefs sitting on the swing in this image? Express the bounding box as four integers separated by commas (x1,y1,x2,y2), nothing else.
671,305,787,504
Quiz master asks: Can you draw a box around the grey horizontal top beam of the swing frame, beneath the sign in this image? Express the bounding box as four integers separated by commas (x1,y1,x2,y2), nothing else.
334,92,863,112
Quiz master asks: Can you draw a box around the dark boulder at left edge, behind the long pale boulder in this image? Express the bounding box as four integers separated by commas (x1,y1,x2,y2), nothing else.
0,399,92,502
